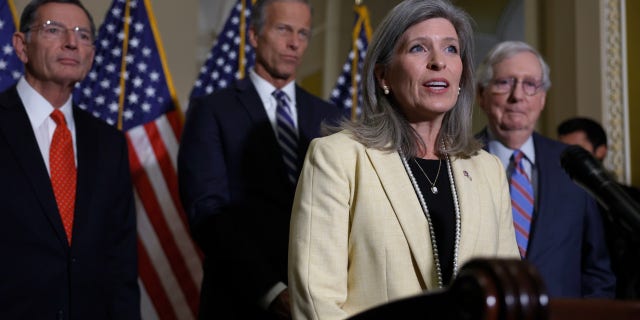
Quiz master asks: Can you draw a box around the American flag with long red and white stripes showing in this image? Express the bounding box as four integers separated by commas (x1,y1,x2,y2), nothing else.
74,0,202,319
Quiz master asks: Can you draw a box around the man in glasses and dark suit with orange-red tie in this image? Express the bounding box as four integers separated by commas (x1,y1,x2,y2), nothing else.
0,0,140,320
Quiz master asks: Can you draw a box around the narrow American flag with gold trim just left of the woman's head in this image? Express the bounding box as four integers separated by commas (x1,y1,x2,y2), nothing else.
330,5,371,119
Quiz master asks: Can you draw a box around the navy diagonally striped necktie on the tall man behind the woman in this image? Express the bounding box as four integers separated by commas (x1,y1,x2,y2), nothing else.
273,90,298,184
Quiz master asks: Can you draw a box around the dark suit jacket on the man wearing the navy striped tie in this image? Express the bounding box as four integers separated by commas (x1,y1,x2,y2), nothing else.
178,78,340,319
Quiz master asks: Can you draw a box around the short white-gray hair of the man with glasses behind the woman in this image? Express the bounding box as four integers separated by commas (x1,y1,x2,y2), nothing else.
477,41,551,92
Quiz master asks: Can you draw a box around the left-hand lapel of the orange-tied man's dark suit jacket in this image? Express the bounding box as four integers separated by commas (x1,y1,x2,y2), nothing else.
0,86,67,247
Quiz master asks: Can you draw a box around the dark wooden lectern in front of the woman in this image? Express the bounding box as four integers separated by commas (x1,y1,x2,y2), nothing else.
349,259,640,320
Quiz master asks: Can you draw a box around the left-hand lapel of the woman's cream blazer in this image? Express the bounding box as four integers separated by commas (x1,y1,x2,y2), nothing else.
367,149,437,288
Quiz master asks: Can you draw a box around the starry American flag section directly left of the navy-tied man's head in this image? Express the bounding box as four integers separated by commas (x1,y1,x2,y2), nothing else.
191,0,255,98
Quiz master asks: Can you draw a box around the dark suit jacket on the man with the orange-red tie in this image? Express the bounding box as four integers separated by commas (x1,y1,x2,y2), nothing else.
0,86,140,320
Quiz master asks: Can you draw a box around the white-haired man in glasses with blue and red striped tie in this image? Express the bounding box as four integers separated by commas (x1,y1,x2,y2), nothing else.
477,41,615,298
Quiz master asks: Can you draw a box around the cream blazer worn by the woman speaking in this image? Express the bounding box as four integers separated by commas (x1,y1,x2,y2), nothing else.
289,131,519,320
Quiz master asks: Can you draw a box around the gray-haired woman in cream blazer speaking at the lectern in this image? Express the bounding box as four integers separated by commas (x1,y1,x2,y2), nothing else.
289,0,519,320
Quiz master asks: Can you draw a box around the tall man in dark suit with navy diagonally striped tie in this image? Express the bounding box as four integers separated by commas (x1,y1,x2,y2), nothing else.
178,0,340,319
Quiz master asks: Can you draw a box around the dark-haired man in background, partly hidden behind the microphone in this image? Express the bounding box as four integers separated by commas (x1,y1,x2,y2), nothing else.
557,117,640,299
